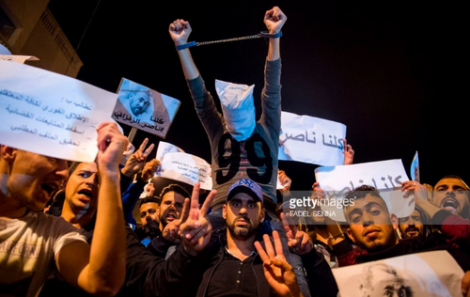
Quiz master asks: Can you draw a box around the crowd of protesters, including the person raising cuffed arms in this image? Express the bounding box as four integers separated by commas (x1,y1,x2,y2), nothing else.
0,7,470,297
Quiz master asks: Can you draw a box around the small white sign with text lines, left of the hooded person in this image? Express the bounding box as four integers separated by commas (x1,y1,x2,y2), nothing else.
157,152,212,190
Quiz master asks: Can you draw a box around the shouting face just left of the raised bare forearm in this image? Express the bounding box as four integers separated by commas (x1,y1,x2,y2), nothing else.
65,162,99,214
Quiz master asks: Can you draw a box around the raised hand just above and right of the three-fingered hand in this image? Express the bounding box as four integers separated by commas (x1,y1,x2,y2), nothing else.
280,212,313,255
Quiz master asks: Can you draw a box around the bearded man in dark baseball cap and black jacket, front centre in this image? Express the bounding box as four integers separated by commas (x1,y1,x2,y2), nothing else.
188,178,302,296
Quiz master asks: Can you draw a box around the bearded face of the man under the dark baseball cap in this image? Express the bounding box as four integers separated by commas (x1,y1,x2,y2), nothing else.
222,191,265,239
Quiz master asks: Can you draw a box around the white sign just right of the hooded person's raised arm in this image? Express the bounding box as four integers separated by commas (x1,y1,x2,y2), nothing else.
279,111,346,166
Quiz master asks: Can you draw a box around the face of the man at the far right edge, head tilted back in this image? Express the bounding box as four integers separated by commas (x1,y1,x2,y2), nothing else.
432,177,470,218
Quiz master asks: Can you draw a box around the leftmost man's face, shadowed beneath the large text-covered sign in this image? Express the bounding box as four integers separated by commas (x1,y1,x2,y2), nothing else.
1,145,68,212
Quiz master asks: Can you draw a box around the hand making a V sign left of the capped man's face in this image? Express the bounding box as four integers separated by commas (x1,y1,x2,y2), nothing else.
179,182,217,255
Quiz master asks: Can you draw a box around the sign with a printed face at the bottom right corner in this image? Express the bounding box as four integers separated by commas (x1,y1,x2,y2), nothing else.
331,251,464,297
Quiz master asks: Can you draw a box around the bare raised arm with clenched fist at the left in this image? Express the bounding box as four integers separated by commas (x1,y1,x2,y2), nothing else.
56,123,128,296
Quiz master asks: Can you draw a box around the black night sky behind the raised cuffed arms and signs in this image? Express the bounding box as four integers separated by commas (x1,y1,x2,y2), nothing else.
49,0,470,190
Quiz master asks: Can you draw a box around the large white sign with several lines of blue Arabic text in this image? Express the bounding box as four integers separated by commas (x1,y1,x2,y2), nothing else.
0,60,117,162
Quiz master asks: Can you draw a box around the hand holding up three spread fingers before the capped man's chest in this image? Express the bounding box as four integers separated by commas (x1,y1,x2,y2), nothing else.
255,231,302,296
